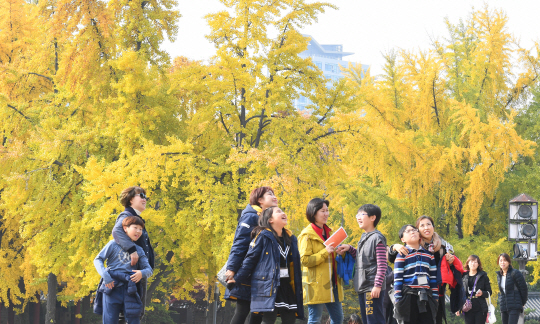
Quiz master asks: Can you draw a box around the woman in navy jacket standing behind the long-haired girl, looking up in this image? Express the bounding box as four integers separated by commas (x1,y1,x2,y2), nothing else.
225,187,278,324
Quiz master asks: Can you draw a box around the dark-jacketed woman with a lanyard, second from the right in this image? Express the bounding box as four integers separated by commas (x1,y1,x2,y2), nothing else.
463,254,491,324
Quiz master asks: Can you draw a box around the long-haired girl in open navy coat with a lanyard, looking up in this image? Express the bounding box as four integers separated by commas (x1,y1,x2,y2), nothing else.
229,207,304,324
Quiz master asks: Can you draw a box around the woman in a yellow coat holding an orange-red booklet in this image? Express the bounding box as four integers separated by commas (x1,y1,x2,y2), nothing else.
298,198,343,324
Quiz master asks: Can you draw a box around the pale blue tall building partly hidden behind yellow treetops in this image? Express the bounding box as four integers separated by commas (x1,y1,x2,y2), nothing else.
294,35,368,110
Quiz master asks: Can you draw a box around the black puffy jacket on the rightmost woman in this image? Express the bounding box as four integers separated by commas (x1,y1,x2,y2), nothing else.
497,267,528,312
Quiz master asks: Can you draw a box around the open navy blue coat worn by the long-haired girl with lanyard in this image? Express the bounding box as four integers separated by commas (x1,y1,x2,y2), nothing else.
234,229,304,319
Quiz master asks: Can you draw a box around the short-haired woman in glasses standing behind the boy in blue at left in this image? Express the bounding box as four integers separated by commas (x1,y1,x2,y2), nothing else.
112,186,154,314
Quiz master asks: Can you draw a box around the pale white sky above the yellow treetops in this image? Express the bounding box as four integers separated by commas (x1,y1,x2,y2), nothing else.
163,0,540,75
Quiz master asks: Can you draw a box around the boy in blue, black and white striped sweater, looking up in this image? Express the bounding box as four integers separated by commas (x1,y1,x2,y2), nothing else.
394,225,439,324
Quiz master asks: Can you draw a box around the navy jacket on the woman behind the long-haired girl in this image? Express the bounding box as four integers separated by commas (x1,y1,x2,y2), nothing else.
225,204,259,300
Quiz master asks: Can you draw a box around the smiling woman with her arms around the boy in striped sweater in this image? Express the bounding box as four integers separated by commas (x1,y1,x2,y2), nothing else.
388,215,454,324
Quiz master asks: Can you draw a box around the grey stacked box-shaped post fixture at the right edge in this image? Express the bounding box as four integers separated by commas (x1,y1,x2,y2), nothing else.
508,194,538,274
